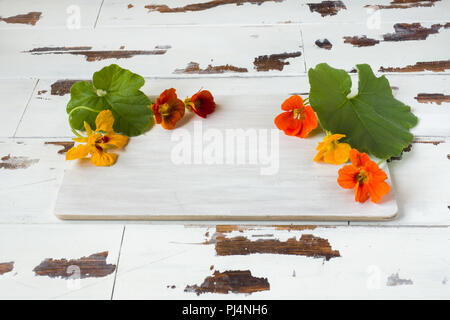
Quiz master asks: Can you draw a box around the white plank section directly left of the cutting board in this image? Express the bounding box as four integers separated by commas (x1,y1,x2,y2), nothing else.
0,139,65,223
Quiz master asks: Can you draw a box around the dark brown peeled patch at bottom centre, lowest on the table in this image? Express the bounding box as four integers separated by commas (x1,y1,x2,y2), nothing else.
184,270,270,295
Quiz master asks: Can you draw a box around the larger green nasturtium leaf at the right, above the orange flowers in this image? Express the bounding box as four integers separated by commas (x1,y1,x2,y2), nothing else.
308,63,418,159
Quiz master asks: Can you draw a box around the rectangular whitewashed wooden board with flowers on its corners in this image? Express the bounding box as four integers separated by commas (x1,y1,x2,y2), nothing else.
55,94,397,220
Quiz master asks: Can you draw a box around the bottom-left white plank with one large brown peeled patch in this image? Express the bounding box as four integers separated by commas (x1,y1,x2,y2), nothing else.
0,224,123,299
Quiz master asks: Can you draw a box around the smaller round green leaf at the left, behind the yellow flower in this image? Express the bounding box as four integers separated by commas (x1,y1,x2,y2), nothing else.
67,64,153,137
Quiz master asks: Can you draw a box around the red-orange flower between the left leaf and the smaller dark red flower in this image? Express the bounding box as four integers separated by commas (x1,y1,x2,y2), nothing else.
151,88,184,130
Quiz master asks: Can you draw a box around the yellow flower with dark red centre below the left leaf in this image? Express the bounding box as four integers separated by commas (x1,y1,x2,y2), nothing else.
66,110,128,166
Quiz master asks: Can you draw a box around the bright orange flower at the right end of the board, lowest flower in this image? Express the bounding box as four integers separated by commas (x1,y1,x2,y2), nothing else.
337,149,391,203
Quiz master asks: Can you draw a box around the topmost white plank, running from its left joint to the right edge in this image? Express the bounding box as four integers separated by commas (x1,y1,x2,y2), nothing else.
97,0,450,27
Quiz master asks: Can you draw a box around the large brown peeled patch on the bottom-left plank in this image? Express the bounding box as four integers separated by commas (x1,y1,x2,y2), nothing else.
33,251,116,279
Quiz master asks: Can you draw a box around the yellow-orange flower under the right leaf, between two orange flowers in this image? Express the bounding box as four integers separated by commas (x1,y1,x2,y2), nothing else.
314,133,352,164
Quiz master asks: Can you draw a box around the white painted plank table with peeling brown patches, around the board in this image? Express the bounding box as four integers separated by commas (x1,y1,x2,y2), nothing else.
0,0,450,299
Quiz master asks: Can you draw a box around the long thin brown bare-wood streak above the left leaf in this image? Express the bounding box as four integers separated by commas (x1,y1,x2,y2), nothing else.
26,47,167,62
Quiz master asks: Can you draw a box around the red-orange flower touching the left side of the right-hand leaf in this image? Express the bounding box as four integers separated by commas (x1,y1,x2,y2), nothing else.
275,95,317,138
